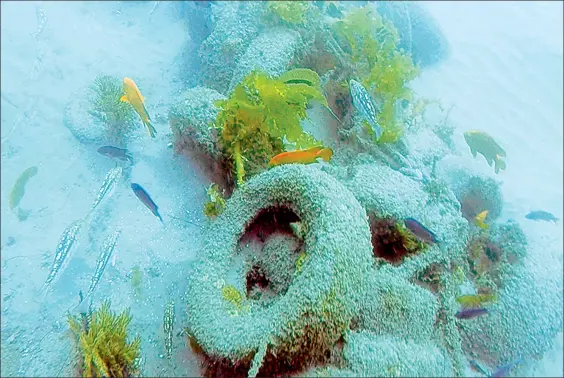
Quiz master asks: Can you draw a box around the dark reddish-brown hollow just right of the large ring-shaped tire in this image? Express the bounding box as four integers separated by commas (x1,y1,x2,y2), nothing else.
368,212,426,265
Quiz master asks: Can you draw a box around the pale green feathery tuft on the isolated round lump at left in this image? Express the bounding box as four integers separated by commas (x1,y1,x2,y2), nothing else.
88,75,136,144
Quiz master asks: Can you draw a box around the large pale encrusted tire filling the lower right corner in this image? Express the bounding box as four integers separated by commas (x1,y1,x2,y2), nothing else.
458,244,563,368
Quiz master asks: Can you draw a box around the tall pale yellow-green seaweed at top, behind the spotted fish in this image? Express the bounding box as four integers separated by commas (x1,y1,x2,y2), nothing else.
335,6,419,143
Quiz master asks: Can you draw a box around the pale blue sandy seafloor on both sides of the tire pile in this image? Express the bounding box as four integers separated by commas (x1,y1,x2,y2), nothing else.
0,2,564,376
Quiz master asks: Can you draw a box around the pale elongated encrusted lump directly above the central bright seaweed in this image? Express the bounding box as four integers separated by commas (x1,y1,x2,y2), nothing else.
229,27,300,93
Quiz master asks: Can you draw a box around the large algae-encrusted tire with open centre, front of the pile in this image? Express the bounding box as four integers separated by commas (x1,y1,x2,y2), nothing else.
187,164,372,376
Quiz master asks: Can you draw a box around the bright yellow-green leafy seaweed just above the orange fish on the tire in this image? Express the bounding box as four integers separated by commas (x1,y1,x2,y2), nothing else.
214,71,327,185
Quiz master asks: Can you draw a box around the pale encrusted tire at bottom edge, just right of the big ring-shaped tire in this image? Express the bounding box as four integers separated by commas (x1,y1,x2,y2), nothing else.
343,331,454,377
